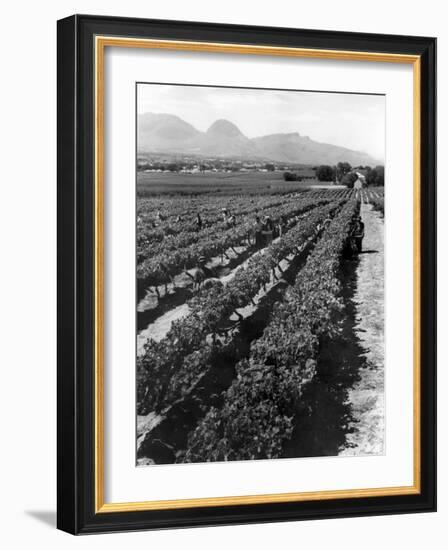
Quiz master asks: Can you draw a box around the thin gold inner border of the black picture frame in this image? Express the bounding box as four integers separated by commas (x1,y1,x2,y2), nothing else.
94,36,421,513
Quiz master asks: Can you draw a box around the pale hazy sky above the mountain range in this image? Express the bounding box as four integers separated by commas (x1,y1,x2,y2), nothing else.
137,84,385,161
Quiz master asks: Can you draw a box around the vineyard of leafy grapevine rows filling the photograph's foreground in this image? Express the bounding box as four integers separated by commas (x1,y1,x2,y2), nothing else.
137,188,384,465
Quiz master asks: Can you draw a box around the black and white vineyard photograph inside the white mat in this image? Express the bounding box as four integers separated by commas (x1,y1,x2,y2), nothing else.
136,83,385,466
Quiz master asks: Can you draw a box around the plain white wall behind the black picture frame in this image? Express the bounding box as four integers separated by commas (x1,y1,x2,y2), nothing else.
0,0,442,550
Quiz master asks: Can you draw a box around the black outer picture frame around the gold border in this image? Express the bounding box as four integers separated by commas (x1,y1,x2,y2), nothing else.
57,15,436,534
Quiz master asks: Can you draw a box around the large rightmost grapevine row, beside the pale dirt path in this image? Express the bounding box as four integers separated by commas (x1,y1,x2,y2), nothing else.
179,200,359,462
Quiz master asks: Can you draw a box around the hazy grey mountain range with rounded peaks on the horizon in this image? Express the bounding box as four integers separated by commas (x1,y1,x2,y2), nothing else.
137,113,380,166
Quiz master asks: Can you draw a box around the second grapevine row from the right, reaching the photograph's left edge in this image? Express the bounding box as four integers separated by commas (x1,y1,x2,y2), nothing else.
137,201,342,414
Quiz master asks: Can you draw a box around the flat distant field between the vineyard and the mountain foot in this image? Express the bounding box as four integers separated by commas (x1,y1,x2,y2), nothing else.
137,172,319,197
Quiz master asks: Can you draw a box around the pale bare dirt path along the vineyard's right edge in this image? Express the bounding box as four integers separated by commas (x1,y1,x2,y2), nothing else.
340,203,385,456
